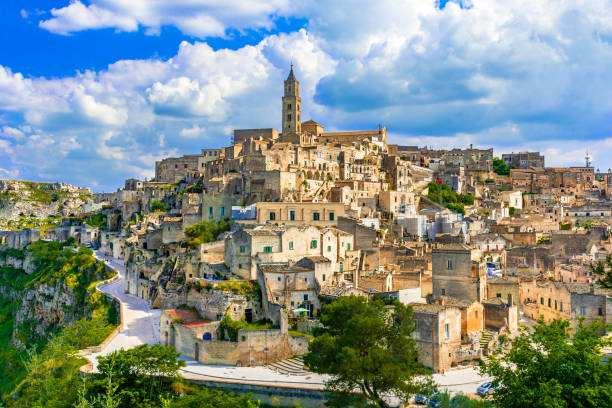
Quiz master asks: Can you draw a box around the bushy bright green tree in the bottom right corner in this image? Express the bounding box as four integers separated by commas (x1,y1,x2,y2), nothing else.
481,319,612,408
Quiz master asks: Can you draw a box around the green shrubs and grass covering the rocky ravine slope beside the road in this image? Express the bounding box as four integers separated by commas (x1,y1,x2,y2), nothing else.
0,241,118,396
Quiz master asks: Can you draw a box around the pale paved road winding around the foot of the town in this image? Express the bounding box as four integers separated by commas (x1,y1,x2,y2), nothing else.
89,252,486,393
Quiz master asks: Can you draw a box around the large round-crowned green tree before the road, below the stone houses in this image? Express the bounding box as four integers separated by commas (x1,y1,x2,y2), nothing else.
304,296,431,408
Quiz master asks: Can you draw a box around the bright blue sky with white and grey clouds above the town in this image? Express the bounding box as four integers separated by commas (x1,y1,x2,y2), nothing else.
0,0,612,191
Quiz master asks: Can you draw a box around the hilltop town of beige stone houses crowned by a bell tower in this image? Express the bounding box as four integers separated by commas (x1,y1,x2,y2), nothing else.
0,67,612,404
